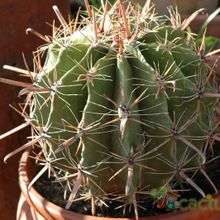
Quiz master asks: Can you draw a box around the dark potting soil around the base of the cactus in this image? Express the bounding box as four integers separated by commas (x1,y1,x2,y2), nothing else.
35,143,220,218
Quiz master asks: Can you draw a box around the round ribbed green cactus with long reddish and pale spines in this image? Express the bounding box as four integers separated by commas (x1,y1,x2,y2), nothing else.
0,0,220,218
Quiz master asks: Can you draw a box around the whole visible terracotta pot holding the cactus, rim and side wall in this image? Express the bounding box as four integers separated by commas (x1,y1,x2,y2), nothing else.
17,151,220,220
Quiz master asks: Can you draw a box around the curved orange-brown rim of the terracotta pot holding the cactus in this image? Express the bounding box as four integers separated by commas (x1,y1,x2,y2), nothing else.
18,150,220,220
